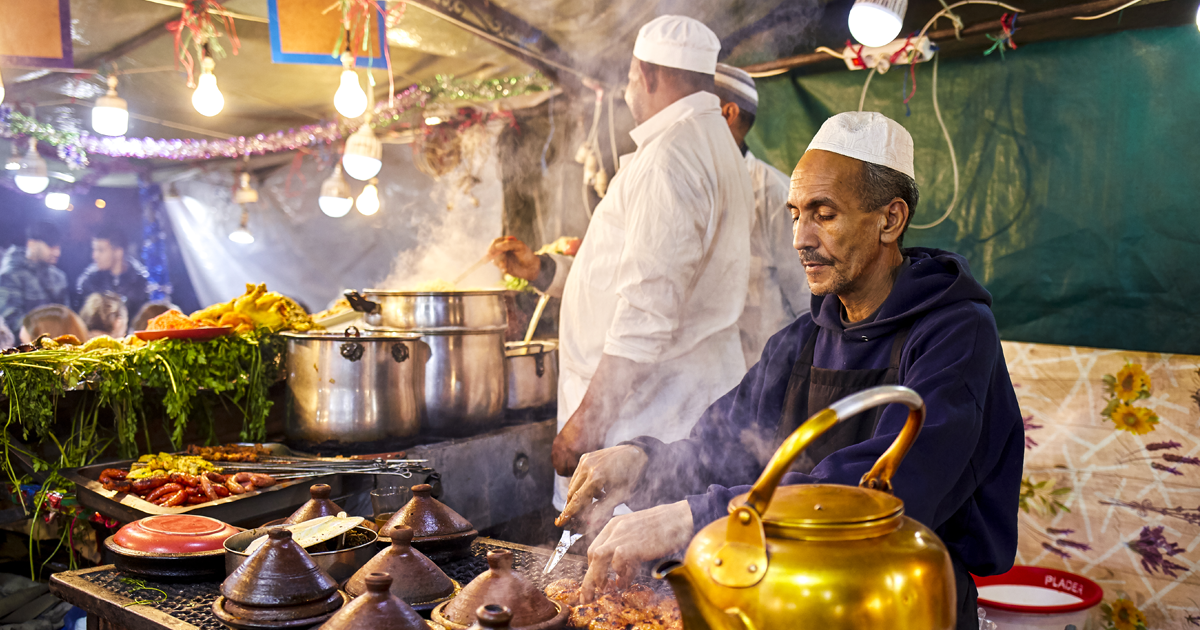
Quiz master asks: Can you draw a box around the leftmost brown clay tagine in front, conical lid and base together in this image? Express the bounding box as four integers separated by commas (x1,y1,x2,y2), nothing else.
212,527,348,630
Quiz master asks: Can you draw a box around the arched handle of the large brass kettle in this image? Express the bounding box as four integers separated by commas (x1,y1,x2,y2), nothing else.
745,385,925,516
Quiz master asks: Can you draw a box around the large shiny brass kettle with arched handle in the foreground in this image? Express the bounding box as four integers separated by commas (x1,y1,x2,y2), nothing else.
655,385,956,630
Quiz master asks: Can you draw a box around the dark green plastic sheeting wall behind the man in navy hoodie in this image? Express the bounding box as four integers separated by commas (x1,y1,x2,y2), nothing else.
748,26,1200,354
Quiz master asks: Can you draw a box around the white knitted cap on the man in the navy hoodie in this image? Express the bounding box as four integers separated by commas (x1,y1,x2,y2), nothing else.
805,112,917,179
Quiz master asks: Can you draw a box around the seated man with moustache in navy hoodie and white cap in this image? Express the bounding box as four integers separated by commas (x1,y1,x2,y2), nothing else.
559,113,1025,629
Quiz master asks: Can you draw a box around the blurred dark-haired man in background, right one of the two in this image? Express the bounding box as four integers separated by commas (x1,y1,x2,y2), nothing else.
74,226,150,313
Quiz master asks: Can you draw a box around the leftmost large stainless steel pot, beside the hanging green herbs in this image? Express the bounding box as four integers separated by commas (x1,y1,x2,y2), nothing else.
283,326,428,442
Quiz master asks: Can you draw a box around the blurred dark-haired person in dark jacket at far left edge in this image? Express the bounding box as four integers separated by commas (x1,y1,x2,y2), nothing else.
0,221,67,330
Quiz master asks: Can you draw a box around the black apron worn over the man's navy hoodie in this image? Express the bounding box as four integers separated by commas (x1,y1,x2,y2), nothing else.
774,326,979,630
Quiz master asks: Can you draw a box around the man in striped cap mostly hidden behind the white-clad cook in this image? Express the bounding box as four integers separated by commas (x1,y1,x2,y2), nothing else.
715,64,812,367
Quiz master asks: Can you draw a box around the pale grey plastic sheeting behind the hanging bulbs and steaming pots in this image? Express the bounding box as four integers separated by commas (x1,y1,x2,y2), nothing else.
166,133,502,311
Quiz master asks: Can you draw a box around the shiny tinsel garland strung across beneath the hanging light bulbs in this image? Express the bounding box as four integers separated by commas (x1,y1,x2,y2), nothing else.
0,74,551,168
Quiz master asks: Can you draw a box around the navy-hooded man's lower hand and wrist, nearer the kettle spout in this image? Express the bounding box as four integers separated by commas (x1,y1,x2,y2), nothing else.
580,500,692,604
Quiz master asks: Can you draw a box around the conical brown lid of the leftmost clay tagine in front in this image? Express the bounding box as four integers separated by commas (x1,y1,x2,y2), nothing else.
221,527,337,607
